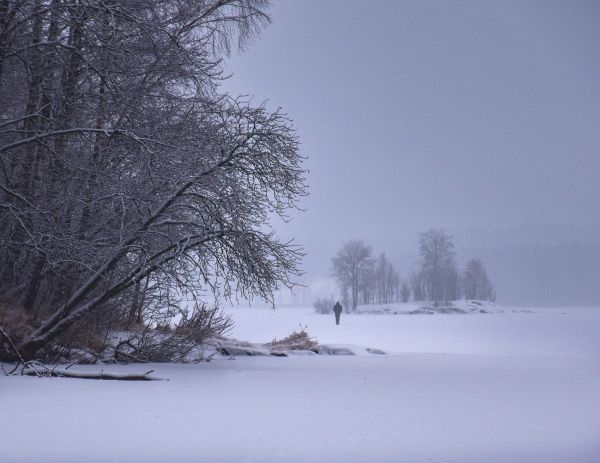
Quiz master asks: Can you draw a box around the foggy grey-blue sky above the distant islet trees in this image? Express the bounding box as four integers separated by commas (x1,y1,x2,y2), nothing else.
223,0,600,304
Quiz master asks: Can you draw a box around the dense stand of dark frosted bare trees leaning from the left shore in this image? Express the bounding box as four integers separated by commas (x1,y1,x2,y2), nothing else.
0,0,306,358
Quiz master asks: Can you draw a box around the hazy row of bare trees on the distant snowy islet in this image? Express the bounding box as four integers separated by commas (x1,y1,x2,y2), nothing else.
332,229,496,311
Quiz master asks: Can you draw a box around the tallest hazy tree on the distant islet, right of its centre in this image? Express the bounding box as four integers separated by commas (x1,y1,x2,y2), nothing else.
419,229,458,306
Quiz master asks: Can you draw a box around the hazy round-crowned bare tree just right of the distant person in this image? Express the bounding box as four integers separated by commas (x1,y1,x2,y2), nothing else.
332,240,373,311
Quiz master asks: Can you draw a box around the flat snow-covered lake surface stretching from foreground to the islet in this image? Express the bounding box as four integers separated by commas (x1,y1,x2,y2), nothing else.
0,308,600,463
